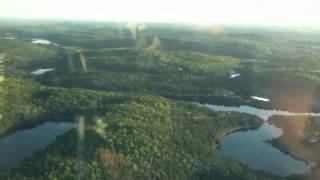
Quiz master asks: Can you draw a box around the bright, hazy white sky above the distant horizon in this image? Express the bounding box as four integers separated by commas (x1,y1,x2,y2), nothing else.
0,0,320,26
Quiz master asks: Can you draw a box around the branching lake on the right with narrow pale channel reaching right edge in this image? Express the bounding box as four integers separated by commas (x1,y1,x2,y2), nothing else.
206,105,320,176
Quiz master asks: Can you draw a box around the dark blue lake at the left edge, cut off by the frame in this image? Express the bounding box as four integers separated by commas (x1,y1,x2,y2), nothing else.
0,122,76,169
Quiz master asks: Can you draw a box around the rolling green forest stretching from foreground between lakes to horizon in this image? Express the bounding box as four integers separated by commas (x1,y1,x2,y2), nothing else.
0,22,320,180
